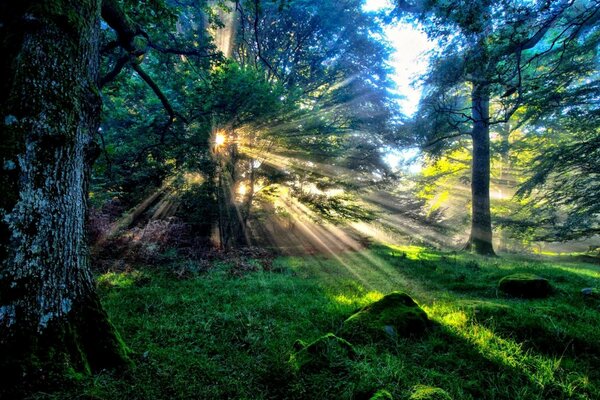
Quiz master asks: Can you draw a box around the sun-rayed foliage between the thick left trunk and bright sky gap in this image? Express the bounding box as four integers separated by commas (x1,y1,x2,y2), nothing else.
92,0,398,239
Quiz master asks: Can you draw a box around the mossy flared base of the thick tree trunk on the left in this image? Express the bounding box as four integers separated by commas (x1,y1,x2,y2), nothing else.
0,293,132,398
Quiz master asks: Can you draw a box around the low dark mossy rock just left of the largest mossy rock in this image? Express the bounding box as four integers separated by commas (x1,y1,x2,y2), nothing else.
289,333,356,372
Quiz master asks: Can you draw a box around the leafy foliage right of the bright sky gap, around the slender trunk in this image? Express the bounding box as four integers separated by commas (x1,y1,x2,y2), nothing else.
394,0,600,250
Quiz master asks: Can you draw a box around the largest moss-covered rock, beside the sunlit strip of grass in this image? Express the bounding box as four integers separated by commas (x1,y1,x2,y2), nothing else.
340,292,432,342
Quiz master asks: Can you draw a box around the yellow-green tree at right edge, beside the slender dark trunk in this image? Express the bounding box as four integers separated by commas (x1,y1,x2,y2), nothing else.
510,105,600,241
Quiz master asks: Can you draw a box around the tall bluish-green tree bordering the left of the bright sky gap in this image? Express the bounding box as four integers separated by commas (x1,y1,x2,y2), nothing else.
234,0,399,195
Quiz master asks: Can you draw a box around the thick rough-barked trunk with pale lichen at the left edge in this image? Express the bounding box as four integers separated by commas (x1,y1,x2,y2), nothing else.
0,0,127,397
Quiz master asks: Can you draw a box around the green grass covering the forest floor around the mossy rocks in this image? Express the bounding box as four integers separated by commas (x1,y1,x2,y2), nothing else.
34,246,600,400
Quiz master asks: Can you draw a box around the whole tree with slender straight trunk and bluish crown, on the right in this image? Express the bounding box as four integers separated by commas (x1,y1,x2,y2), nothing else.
396,0,599,255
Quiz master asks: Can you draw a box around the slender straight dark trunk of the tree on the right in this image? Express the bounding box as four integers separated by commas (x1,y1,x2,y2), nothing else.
466,84,495,255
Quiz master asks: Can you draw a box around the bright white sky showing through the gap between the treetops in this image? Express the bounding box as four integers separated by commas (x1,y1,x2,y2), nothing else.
363,0,434,173
